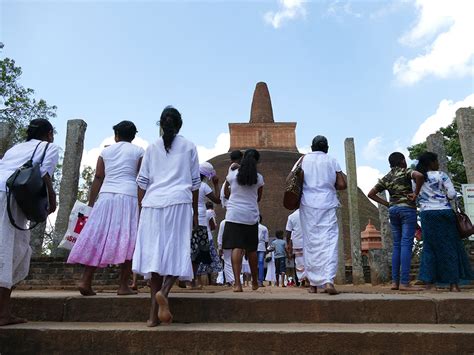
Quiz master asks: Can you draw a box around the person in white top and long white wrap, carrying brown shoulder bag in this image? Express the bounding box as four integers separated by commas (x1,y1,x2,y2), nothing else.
300,136,347,295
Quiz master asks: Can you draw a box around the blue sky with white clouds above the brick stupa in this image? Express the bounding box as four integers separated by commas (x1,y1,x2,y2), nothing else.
0,0,474,195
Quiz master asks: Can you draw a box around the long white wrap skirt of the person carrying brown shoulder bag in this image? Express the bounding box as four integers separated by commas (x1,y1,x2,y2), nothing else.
300,206,339,286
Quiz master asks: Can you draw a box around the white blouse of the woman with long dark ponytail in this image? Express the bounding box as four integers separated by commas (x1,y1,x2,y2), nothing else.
137,135,201,208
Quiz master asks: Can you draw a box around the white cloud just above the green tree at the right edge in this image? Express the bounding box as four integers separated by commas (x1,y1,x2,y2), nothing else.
412,94,474,144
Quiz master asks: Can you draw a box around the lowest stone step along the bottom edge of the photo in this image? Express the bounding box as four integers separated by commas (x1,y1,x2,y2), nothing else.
0,322,474,355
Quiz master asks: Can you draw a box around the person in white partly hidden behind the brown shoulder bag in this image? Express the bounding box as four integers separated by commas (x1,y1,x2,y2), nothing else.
286,210,306,283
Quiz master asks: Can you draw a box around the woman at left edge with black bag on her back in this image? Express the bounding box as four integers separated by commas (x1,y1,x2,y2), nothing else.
0,119,59,326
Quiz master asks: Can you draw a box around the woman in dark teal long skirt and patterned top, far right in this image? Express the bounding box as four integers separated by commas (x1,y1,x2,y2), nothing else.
416,152,474,292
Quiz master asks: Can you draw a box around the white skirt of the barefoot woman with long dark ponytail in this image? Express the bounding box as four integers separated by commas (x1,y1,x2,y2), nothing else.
132,203,193,280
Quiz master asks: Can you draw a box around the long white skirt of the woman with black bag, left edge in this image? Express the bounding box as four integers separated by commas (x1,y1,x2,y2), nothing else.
0,191,31,289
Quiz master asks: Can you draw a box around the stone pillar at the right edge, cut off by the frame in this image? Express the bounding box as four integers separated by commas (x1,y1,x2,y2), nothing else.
456,107,474,184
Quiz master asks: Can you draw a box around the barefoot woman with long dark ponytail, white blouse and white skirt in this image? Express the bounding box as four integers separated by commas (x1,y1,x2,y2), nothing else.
132,106,201,327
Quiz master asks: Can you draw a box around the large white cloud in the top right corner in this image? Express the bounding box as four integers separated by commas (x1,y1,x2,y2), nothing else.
393,0,474,85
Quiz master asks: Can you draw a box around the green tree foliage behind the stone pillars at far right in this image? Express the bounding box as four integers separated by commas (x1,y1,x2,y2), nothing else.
408,120,467,187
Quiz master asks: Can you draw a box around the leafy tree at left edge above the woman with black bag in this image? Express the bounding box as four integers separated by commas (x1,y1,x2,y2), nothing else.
0,43,57,143
